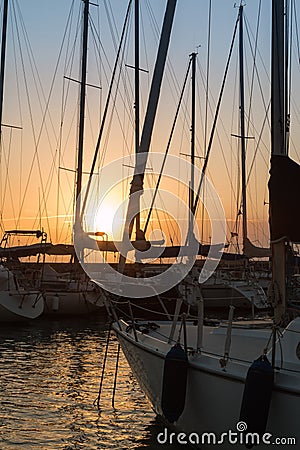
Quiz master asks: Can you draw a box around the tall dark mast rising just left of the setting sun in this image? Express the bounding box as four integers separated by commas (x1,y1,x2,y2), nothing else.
75,0,89,229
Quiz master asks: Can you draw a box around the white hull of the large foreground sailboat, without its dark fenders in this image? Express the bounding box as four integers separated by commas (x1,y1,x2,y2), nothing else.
115,323,300,449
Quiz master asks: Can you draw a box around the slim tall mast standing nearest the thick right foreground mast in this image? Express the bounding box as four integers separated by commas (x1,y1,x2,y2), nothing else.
239,4,247,247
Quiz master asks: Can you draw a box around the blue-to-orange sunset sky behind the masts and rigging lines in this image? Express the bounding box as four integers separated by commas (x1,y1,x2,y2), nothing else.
0,0,299,251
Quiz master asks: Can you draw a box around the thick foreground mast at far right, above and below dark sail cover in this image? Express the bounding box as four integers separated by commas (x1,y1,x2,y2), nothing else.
270,0,287,325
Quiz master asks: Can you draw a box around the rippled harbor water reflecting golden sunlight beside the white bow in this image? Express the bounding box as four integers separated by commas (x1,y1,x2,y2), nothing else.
0,317,186,450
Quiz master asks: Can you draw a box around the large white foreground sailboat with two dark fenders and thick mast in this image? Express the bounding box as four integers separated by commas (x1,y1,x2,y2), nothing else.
96,0,300,449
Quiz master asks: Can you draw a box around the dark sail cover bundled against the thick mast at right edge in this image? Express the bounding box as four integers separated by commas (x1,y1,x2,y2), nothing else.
269,155,300,243
